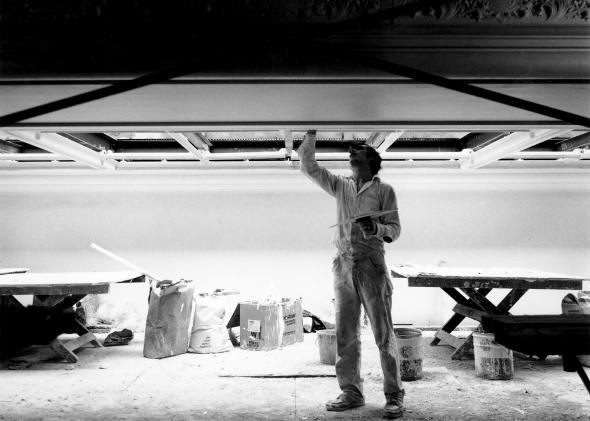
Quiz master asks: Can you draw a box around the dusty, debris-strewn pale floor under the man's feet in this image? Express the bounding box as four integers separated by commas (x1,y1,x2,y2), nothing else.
0,332,590,420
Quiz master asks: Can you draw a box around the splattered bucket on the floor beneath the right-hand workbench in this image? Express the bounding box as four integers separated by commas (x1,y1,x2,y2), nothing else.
473,333,514,380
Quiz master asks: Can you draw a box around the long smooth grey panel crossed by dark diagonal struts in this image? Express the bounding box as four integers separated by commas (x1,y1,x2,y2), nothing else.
0,82,590,130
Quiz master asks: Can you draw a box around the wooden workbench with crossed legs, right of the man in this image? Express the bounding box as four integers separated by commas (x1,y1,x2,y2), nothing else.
391,264,588,359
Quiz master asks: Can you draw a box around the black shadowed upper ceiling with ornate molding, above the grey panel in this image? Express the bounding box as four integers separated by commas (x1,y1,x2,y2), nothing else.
0,0,590,80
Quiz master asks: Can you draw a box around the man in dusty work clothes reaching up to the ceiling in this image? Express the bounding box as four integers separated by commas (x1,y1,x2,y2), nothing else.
297,130,404,419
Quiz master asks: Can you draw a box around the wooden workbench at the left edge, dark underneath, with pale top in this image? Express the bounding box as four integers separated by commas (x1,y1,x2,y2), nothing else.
0,270,145,362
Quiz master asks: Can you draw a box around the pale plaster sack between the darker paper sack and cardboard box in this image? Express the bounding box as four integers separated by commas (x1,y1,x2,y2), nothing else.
188,294,232,354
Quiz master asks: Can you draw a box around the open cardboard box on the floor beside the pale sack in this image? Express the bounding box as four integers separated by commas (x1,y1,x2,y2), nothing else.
240,298,303,351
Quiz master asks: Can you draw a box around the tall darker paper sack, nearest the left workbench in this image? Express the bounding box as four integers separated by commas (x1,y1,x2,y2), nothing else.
143,279,194,358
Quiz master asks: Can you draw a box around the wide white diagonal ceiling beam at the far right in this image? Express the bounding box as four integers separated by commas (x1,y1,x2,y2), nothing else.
461,129,569,169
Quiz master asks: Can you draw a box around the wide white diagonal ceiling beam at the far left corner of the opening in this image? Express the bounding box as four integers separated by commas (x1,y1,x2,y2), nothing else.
0,131,117,170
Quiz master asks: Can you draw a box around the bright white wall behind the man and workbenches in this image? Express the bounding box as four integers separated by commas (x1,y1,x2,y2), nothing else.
0,170,590,325
